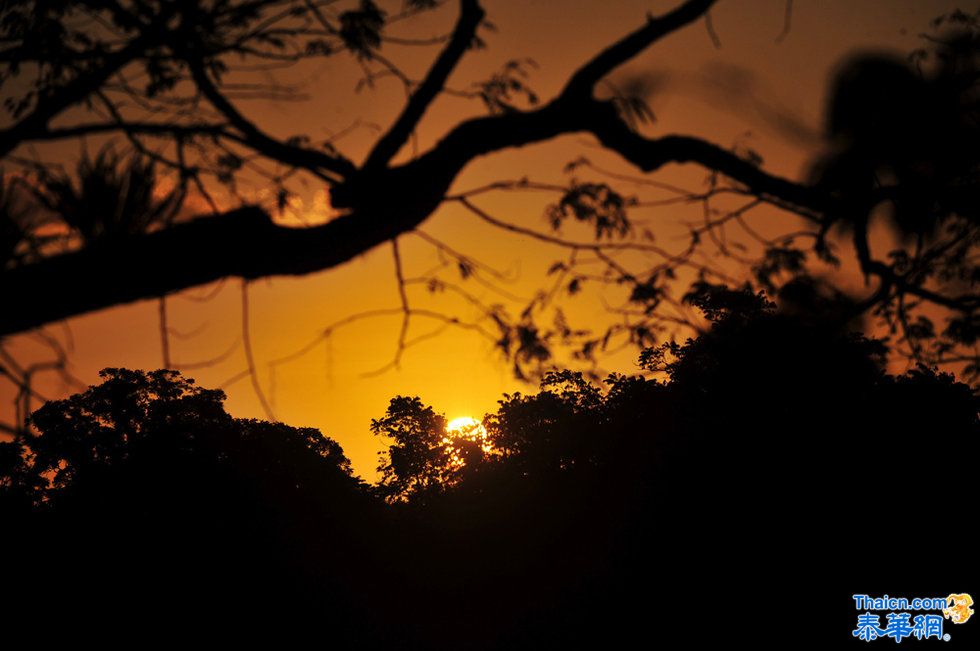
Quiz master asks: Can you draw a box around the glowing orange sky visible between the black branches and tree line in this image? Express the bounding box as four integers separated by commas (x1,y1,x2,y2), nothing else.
0,0,956,479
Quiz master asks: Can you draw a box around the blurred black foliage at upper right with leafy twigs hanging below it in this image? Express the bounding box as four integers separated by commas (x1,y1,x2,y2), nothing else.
804,17,980,378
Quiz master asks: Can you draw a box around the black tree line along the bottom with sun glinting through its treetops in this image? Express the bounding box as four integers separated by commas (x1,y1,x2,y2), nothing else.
0,288,978,649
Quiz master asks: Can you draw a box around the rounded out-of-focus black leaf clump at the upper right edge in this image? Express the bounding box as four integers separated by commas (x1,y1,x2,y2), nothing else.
817,28,980,237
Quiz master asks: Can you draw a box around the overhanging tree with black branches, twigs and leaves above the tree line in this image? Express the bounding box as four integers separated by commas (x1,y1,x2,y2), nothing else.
0,0,980,412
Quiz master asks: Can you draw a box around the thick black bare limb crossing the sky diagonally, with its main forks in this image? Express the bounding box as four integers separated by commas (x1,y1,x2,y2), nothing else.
0,0,844,335
